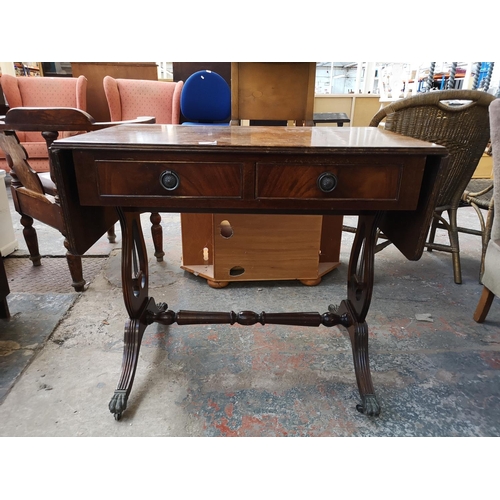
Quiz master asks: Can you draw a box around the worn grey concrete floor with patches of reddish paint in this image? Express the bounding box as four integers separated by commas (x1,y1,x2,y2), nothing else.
0,178,500,437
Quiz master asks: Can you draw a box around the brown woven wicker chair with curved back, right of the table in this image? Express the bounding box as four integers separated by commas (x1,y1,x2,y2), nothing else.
370,90,495,283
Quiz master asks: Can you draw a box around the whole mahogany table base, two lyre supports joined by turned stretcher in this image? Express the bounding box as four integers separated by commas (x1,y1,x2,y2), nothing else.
109,209,380,420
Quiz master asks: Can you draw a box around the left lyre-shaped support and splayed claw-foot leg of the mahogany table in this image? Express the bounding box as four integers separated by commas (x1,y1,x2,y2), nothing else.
109,209,149,420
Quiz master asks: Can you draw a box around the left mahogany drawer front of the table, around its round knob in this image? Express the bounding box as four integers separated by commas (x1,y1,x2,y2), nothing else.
96,160,243,198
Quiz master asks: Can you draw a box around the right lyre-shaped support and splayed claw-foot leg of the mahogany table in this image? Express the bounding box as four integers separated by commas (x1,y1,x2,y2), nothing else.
339,215,380,416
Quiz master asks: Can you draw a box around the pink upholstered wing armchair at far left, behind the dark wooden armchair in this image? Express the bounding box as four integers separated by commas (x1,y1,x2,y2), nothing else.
0,75,87,172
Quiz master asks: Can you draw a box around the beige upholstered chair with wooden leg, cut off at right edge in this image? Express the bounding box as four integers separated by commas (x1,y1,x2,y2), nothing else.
474,99,500,323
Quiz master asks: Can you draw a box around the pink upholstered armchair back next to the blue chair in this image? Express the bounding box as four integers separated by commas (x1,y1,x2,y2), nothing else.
103,76,183,125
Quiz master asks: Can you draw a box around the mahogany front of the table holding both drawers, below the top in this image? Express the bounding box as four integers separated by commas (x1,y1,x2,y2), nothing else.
74,151,425,214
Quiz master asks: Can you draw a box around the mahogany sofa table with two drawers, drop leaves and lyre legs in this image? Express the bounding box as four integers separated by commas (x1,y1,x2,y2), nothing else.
50,125,447,420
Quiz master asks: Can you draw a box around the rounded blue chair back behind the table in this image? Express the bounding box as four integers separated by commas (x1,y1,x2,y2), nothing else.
181,70,231,125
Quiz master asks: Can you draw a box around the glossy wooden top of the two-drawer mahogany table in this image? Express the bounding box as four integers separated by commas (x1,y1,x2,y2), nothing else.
52,124,447,155
